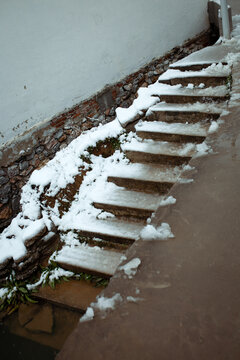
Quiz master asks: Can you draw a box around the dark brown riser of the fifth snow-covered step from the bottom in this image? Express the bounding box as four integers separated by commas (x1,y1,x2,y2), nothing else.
125,151,191,165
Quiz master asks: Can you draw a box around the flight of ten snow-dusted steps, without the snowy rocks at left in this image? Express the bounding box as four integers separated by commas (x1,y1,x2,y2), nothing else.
53,55,230,284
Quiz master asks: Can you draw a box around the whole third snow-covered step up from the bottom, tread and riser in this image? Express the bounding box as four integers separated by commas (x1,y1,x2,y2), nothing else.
93,186,163,219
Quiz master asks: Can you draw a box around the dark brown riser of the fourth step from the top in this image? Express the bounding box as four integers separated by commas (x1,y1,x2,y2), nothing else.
145,111,219,124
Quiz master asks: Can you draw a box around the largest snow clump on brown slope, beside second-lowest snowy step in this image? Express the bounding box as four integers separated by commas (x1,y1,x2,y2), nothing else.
140,223,174,241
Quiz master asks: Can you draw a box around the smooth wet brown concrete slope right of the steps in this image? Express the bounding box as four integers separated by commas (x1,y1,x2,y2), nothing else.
57,58,240,360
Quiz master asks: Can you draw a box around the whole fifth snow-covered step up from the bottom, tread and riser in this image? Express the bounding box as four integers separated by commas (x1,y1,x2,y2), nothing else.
122,140,195,165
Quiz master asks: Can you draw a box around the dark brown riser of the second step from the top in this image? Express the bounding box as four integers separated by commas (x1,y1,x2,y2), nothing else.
159,76,227,87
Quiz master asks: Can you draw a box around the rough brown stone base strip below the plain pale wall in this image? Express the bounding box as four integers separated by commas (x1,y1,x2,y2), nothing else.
0,31,211,231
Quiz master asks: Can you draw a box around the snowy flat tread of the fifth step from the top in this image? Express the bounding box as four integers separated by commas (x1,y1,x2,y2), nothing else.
135,121,207,136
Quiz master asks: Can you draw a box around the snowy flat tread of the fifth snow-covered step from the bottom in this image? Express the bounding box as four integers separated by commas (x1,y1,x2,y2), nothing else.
122,139,195,157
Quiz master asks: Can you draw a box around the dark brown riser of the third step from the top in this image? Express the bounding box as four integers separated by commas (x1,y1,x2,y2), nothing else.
158,95,229,104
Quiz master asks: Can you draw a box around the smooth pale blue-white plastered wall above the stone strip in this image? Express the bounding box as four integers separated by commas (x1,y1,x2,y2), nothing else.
0,0,208,148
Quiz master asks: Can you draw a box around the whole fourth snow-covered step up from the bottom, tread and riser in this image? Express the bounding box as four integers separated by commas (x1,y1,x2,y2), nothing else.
108,163,181,194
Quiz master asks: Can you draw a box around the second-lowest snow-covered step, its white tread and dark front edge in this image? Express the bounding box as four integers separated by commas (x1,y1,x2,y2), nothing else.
60,215,144,243
